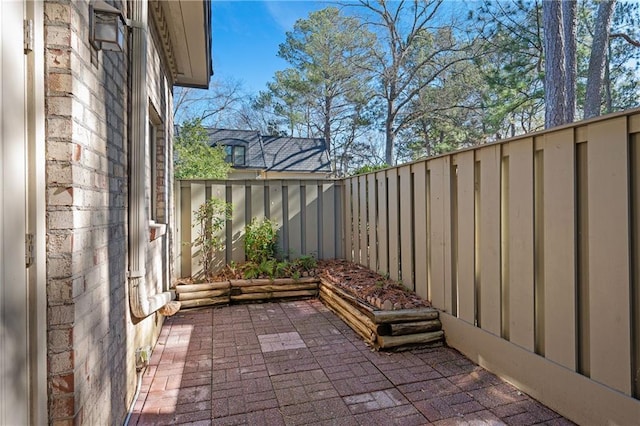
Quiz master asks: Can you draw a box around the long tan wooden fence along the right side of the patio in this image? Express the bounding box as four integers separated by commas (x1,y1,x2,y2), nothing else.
344,110,640,424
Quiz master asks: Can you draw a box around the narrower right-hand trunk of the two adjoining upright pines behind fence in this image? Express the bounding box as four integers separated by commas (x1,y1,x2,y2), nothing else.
562,0,578,123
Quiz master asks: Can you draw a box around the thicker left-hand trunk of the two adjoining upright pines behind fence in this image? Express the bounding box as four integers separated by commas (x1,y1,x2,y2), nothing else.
542,0,567,128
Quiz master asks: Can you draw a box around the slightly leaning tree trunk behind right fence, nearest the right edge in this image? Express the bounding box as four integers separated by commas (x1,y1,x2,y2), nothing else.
584,0,615,118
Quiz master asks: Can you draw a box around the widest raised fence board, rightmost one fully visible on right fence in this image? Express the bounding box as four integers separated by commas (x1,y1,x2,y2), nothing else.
587,117,631,395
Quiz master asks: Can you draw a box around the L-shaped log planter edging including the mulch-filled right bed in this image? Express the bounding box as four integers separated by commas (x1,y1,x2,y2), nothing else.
176,261,444,350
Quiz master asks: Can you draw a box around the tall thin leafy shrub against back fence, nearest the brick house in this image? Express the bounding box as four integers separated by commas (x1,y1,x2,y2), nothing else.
193,198,231,276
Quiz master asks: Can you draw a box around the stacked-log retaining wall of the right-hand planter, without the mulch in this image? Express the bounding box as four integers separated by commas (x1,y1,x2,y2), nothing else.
319,278,444,350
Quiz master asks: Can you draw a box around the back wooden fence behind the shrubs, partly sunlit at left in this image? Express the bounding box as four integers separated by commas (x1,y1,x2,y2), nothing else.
176,180,343,277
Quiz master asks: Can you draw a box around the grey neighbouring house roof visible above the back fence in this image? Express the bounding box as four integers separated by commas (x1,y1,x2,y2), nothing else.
207,128,331,173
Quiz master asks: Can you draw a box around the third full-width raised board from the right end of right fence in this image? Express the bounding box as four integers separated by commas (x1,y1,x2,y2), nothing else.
503,138,535,351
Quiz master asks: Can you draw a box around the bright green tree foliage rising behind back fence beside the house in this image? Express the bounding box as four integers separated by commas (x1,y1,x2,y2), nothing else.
174,119,230,179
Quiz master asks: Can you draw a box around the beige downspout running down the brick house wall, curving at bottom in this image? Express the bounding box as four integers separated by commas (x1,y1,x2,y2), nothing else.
128,0,172,318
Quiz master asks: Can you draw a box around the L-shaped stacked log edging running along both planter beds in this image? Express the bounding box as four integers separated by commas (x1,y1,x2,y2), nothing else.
176,277,444,350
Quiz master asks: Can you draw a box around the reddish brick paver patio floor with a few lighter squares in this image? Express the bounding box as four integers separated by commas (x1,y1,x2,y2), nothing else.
129,300,572,425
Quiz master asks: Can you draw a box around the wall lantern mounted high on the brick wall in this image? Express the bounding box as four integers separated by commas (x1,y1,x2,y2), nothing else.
89,0,127,52
